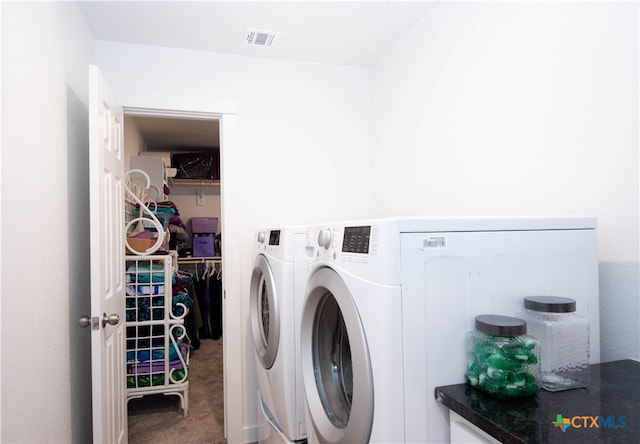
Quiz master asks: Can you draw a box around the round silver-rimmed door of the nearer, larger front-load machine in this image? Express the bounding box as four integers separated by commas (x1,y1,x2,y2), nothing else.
300,268,374,443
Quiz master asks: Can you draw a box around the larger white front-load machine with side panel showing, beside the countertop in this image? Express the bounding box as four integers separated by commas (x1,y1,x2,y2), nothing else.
300,217,600,443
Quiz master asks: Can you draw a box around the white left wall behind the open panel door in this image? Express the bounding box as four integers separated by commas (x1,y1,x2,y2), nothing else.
0,2,93,443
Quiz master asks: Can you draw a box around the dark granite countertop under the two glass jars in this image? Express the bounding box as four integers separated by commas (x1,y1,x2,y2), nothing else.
435,360,640,444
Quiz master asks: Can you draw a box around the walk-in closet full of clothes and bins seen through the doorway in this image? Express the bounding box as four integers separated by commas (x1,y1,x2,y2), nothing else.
123,112,224,444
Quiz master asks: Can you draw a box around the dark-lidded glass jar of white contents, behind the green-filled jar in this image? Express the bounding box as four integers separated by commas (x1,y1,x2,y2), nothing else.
517,296,589,392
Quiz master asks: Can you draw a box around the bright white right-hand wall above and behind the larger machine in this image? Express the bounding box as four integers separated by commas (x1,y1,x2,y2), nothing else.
370,2,640,361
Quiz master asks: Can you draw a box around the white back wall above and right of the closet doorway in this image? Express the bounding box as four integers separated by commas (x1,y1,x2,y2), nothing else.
96,42,373,442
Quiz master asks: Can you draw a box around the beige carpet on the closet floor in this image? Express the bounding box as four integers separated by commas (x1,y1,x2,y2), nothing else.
128,338,225,444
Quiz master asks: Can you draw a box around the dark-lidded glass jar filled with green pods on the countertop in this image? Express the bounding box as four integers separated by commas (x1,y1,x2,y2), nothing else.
465,315,540,399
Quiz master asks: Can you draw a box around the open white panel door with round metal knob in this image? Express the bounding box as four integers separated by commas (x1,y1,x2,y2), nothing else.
89,66,127,443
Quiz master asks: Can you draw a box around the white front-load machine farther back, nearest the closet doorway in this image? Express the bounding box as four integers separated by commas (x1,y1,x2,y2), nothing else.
250,226,306,442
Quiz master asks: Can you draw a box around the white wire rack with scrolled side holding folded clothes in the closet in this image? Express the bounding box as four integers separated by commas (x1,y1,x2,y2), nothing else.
125,255,190,416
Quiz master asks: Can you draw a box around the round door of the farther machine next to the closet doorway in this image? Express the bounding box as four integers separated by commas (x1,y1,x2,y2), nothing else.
249,254,280,369
